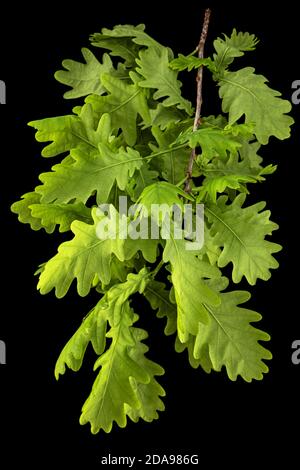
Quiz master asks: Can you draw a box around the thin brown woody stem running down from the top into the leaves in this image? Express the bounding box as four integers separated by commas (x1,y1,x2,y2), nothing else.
184,8,211,193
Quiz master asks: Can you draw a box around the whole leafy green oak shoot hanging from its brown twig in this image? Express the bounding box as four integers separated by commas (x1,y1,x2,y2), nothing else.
12,10,293,433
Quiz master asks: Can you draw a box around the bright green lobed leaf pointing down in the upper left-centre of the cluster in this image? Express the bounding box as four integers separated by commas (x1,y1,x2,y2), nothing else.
86,72,151,146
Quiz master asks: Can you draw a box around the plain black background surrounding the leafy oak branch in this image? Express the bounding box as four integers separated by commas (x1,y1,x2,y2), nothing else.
0,1,300,469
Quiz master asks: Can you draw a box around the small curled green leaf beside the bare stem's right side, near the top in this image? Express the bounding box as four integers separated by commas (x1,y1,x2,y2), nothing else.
213,29,258,74
